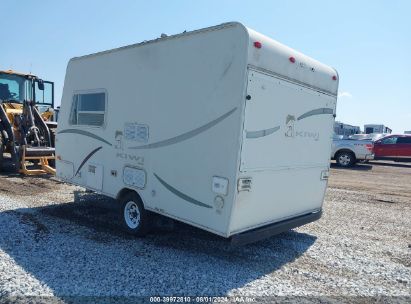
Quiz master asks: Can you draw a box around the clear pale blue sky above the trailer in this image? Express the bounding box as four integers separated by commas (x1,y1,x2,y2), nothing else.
0,0,411,133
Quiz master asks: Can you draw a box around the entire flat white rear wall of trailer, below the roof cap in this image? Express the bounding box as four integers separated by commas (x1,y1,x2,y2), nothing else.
230,71,336,234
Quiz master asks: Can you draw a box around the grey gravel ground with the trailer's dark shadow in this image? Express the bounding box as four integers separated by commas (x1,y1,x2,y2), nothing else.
0,162,411,300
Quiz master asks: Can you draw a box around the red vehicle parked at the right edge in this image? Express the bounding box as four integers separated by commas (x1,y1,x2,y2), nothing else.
374,135,411,162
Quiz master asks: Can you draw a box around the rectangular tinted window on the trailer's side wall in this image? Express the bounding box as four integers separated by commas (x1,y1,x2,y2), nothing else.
70,92,106,127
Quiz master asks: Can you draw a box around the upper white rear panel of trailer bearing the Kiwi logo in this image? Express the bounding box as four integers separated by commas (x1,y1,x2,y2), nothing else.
240,70,336,172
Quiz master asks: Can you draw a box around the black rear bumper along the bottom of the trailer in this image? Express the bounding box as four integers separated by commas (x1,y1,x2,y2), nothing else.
231,210,322,247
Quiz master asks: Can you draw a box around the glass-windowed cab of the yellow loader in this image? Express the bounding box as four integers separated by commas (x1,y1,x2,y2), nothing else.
0,71,54,113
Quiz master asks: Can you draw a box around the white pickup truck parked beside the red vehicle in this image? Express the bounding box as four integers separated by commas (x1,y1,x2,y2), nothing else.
331,138,374,167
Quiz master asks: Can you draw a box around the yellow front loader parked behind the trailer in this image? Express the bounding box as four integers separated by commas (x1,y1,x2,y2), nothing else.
0,70,57,175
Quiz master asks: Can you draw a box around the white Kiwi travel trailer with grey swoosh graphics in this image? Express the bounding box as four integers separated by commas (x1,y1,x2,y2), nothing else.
56,23,338,244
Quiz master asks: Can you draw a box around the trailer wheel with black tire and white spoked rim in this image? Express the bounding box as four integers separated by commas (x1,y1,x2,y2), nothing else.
120,192,148,236
